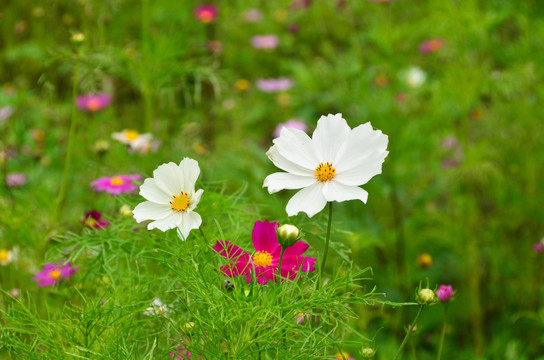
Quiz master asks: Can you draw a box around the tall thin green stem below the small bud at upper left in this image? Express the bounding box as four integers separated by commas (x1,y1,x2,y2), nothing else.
53,44,81,220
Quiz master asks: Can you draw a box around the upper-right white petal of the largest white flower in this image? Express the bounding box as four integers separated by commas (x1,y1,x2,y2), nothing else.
333,123,389,172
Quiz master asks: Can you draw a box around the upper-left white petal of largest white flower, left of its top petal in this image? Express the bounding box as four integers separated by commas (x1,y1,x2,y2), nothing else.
273,127,319,170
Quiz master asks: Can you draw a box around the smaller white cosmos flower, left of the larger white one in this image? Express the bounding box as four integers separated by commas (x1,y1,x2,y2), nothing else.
133,158,204,240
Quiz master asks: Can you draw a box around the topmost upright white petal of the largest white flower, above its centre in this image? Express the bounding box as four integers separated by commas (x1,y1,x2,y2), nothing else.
312,114,351,162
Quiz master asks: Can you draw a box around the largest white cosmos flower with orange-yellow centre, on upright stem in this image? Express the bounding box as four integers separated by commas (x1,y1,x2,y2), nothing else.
263,114,388,217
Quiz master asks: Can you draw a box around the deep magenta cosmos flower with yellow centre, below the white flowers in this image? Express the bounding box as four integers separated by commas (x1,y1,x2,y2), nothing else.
213,220,316,284
